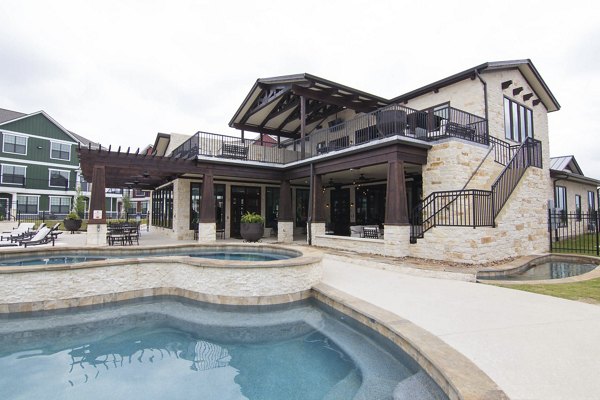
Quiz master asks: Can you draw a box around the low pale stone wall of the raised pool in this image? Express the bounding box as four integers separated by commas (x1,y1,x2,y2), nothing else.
0,250,322,313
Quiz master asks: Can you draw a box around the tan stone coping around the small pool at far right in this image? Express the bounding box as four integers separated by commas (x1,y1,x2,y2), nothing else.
477,253,600,285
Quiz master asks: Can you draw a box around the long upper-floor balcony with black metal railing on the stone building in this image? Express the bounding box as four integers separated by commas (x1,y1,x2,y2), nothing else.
171,104,489,164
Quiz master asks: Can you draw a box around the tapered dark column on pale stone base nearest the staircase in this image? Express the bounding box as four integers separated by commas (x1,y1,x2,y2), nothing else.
384,160,410,257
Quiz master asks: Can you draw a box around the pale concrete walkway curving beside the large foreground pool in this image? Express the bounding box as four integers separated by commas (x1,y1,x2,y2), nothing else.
323,256,600,400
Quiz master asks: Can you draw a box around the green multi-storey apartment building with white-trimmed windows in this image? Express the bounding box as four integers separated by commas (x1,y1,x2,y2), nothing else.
0,109,120,219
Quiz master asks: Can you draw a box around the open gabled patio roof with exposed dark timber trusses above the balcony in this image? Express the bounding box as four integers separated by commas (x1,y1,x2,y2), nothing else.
229,74,389,139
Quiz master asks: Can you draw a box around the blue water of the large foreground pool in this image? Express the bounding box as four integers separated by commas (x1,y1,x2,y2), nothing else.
0,298,446,400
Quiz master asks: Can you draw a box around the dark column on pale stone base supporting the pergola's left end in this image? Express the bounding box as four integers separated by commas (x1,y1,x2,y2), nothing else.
86,165,106,246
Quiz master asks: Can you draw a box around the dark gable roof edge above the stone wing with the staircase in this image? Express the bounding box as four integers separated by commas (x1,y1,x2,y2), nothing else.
391,59,560,112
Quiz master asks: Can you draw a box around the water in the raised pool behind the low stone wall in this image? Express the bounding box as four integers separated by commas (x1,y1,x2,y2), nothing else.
0,250,291,267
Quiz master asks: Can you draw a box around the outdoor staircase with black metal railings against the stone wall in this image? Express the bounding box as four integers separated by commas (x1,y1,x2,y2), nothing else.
410,137,542,243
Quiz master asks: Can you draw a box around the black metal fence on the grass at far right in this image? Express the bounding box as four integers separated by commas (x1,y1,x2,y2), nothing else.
548,210,600,256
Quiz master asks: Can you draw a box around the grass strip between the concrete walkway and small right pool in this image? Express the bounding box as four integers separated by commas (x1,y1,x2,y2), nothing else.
498,278,600,304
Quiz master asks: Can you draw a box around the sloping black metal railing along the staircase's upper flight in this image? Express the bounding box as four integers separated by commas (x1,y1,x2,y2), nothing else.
492,138,542,218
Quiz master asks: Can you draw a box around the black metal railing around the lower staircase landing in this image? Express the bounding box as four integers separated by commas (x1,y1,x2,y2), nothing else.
411,189,494,239
